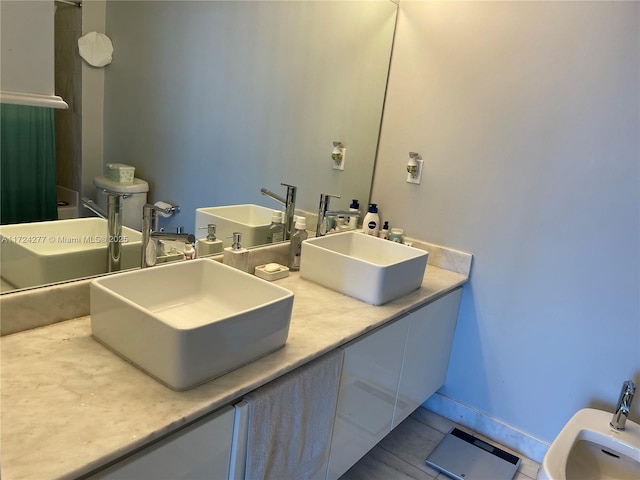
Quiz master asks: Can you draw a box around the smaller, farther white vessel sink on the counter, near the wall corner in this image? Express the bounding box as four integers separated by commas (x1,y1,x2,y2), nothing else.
300,232,428,305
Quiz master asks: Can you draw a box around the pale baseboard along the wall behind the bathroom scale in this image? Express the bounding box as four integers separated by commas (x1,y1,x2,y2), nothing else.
422,392,549,463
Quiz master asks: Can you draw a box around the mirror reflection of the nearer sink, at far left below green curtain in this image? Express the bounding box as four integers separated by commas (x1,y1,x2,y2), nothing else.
0,218,142,288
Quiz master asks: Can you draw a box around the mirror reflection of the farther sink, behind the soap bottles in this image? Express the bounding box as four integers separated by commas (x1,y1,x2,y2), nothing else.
196,204,275,247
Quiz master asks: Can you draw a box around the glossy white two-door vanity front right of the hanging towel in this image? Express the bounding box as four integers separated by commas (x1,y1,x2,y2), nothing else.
327,288,462,480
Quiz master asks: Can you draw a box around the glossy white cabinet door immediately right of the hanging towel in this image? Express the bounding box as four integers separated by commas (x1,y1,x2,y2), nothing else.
327,317,408,479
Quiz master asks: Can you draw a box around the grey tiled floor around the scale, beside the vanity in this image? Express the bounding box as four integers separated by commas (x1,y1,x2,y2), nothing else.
340,408,540,480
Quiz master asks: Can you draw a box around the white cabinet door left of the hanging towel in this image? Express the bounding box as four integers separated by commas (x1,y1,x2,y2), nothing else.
90,407,234,480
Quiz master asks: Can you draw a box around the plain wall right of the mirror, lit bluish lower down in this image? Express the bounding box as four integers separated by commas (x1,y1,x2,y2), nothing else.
372,1,640,442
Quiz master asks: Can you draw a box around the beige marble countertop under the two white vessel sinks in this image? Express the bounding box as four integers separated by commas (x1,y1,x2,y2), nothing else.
0,265,468,480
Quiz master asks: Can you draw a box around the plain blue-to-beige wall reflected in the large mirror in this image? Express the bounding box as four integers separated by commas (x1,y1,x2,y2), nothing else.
0,0,397,291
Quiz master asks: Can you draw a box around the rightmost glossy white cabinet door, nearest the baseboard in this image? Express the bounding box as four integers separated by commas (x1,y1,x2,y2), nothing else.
392,288,462,428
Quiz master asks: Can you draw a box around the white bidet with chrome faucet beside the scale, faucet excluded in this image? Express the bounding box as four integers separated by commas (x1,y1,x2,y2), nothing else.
538,408,640,480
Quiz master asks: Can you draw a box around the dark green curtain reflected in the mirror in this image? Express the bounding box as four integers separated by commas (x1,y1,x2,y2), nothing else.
0,104,58,225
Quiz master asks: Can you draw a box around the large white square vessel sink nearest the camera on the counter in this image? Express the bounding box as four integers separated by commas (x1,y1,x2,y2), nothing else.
91,259,293,390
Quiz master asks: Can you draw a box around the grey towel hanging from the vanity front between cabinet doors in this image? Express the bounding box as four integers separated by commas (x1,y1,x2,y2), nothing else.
245,349,344,480
